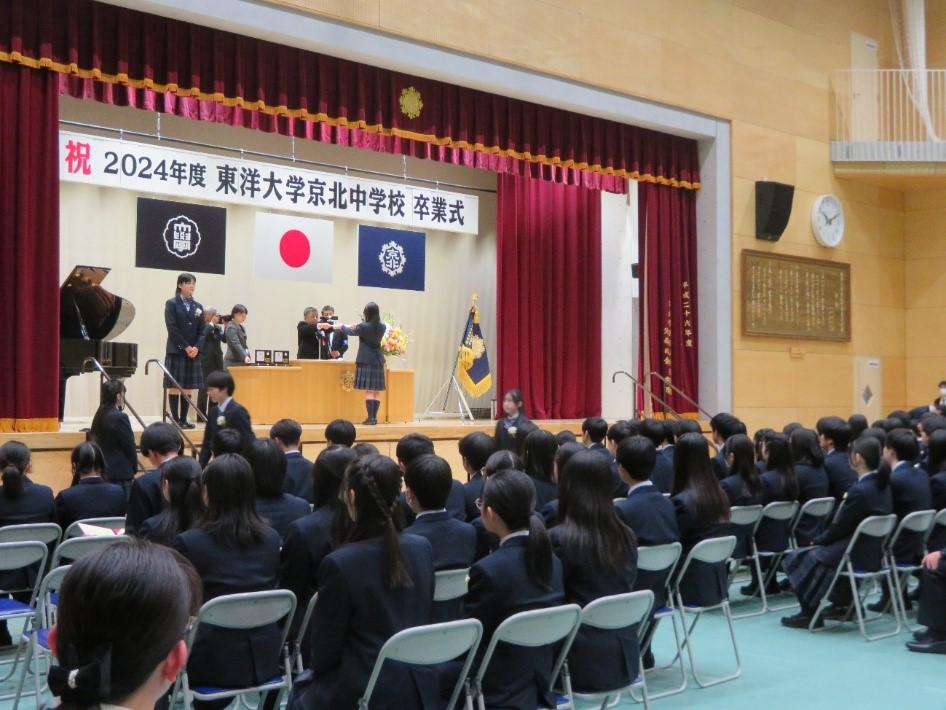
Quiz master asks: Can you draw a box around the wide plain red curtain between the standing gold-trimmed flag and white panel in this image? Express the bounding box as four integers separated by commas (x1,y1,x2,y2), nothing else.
496,175,596,419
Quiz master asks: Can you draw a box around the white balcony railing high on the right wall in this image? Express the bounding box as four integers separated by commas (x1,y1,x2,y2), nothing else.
831,69,946,162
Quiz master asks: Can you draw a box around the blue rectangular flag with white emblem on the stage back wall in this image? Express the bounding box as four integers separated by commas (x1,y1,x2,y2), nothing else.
358,224,427,291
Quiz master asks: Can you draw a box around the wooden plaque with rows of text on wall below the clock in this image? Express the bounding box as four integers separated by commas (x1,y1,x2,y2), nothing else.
742,249,851,341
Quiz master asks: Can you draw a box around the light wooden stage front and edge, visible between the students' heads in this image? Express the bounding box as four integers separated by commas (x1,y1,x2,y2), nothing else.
14,415,583,493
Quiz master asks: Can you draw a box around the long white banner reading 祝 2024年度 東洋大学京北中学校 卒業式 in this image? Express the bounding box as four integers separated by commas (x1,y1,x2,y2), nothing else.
59,131,479,234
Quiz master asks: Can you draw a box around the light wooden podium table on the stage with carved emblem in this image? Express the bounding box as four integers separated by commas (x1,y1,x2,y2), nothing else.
229,360,414,424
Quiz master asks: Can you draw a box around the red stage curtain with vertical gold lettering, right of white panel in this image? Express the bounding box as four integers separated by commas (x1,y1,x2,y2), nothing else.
638,183,699,414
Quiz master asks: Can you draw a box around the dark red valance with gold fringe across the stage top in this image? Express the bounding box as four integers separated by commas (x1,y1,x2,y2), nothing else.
0,0,699,192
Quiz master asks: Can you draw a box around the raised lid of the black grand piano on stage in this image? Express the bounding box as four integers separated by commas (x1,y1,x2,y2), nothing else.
59,266,135,340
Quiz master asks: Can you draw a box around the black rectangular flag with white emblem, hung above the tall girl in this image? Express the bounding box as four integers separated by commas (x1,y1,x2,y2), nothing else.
135,197,227,274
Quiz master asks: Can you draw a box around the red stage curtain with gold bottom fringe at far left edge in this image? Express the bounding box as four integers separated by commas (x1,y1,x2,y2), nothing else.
0,62,59,431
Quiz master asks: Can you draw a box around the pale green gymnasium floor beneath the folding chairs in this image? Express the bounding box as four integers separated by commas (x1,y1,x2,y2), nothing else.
0,599,946,710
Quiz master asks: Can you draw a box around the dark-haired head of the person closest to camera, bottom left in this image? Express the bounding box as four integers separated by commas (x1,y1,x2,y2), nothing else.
49,539,201,710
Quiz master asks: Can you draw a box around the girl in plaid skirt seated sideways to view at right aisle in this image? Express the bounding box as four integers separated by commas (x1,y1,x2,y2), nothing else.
782,436,893,629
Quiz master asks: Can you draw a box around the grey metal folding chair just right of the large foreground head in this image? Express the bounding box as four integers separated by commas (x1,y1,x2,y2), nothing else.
172,588,296,710
